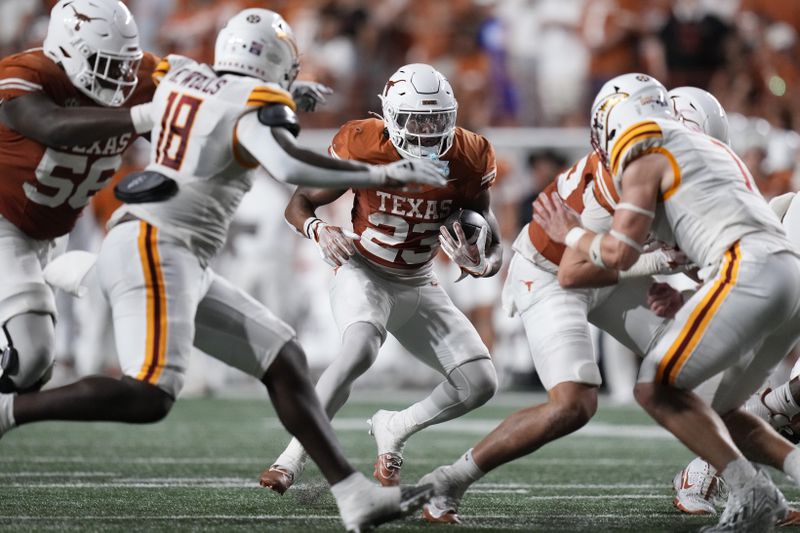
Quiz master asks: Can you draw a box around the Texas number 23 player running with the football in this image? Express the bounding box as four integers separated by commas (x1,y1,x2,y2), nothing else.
261,64,502,494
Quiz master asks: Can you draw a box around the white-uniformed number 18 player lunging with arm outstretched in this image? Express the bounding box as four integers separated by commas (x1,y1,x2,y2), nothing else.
0,9,445,530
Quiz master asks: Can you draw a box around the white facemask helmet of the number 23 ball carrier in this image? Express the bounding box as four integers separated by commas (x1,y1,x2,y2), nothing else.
378,63,458,159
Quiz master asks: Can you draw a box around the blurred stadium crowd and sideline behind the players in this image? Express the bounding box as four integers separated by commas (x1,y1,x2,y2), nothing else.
0,0,800,402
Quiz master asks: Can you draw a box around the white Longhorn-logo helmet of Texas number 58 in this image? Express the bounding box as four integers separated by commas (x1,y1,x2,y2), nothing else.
43,0,143,107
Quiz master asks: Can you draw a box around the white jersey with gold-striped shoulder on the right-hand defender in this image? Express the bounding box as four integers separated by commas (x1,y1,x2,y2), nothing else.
603,119,791,267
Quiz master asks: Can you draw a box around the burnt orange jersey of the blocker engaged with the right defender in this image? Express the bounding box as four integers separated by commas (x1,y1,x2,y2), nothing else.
528,150,613,265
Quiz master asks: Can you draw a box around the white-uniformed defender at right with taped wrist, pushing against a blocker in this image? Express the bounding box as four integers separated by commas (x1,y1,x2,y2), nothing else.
536,74,800,531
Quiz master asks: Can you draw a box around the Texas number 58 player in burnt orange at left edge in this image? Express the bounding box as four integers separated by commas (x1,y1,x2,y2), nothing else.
0,0,157,393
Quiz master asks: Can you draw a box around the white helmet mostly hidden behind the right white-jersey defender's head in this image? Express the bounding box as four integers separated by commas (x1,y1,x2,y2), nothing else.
668,87,731,145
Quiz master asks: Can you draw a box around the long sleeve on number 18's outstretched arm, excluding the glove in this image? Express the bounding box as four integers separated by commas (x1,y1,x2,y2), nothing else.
236,113,383,188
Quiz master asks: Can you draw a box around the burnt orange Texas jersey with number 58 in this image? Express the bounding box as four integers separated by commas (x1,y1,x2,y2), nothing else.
0,48,158,239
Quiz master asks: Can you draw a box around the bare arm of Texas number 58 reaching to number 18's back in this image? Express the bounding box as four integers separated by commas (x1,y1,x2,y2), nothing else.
0,92,153,148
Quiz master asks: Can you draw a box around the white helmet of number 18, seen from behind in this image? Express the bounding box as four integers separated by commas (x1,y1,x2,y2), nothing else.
214,8,300,90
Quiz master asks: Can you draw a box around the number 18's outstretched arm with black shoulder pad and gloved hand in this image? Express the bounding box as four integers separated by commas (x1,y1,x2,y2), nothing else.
236,104,446,189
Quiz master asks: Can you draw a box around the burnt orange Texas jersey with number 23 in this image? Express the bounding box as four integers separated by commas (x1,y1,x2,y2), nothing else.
329,118,497,270
